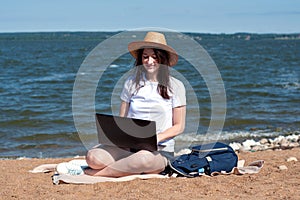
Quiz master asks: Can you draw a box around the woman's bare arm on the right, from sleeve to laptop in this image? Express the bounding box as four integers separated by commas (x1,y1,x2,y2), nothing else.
157,106,186,142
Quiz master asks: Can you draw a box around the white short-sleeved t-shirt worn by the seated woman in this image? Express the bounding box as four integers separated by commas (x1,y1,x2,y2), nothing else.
121,76,186,152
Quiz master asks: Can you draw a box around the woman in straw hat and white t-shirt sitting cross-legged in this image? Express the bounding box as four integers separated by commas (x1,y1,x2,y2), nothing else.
56,32,186,177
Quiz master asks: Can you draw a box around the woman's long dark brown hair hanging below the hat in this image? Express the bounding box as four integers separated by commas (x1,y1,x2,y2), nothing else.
135,48,171,99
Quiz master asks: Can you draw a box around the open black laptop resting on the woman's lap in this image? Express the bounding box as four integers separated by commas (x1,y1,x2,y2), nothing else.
96,113,157,151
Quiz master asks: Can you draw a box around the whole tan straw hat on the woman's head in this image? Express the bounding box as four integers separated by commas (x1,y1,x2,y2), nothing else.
128,32,178,66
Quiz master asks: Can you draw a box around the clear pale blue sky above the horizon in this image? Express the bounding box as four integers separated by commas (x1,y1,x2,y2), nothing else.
0,0,300,33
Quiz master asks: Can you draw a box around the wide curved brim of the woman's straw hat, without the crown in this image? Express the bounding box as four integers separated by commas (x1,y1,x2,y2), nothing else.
128,41,178,67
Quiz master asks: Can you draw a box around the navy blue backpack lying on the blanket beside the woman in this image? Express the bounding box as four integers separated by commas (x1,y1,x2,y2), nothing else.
169,142,238,177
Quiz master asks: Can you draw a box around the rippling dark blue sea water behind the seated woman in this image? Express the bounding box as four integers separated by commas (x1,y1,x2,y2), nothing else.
0,32,300,159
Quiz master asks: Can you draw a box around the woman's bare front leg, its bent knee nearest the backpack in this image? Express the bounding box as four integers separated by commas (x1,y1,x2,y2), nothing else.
85,150,167,177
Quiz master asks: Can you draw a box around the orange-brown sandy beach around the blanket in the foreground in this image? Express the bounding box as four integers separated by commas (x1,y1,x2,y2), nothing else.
0,148,300,200
